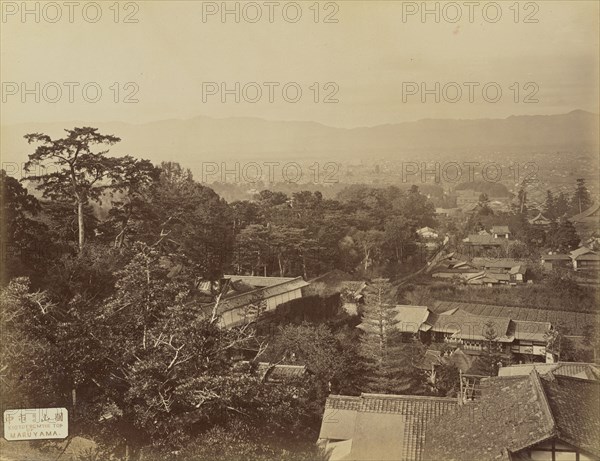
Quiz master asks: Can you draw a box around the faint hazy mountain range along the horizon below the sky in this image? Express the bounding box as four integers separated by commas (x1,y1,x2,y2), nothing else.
1,110,600,170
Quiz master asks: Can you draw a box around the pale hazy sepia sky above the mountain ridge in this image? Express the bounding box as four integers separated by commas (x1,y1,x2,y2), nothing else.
0,0,600,127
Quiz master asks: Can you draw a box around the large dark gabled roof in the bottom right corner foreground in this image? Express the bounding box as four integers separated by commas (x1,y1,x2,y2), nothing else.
424,370,600,461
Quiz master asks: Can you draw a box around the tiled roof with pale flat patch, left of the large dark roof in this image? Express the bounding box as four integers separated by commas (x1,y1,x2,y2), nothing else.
319,394,458,461
